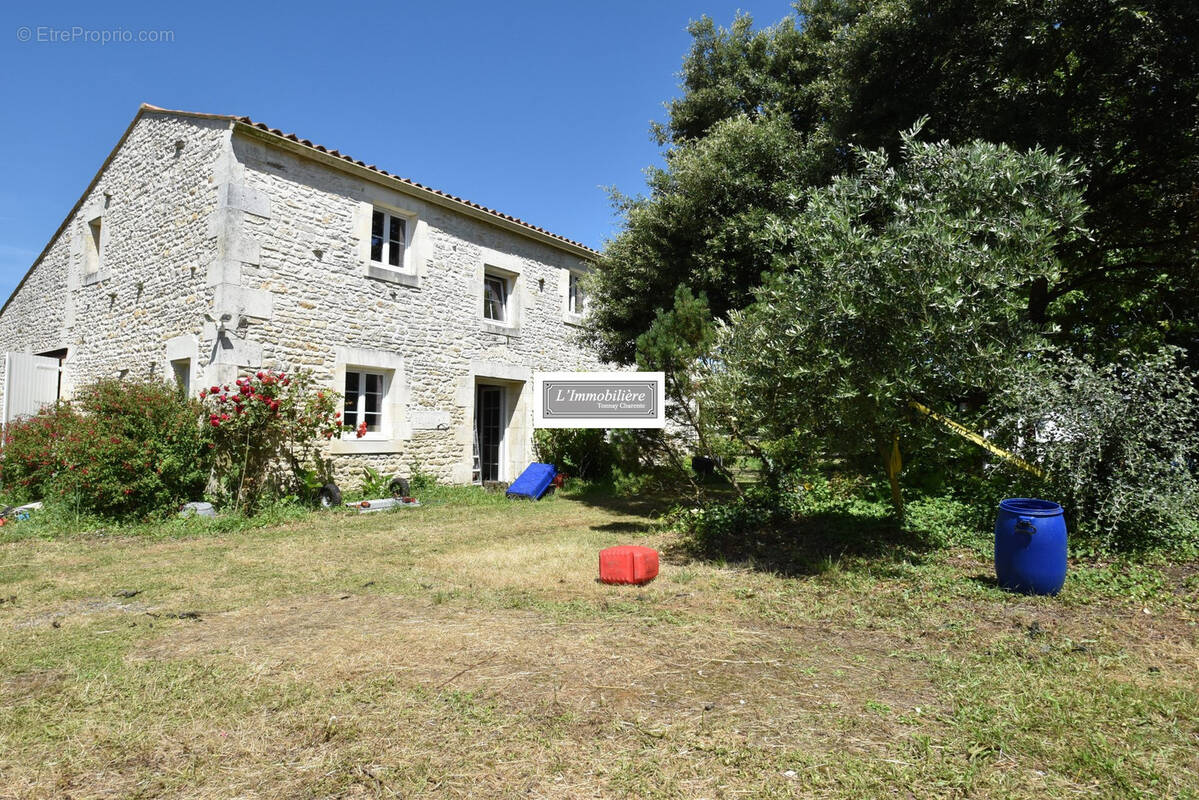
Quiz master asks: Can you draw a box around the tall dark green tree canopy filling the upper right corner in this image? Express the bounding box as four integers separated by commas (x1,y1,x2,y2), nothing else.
595,0,1199,362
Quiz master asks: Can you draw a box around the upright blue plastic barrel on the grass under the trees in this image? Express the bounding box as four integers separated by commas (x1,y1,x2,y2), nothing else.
995,498,1066,595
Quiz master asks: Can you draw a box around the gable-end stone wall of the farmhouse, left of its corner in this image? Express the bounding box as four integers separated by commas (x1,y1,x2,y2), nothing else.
0,112,230,407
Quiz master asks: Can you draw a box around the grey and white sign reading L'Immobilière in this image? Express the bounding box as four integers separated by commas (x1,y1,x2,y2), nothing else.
534,372,665,428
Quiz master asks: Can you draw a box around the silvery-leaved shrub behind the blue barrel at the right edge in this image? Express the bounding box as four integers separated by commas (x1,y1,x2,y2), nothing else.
996,349,1199,551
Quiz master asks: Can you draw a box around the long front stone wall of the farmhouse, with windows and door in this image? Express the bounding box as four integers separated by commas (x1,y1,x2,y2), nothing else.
224,134,602,485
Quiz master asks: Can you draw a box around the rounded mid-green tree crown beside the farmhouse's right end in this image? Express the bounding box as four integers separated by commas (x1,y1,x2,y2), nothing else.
589,116,813,362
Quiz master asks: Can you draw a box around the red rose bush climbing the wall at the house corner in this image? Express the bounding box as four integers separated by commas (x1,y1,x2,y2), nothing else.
200,369,344,512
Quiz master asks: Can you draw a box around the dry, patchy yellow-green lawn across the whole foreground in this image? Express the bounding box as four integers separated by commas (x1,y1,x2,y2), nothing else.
0,495,1199,800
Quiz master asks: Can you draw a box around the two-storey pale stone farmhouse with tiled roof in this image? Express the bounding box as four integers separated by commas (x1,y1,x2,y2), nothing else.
0,106,604,483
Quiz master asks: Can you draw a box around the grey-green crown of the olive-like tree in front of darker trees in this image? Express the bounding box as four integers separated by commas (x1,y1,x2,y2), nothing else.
707,133,1086,474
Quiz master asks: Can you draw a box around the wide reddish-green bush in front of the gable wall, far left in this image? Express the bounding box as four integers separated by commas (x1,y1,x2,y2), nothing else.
0,380,211,517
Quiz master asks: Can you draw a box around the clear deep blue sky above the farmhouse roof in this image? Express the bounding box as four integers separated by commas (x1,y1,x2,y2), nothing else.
0,0,789,297
